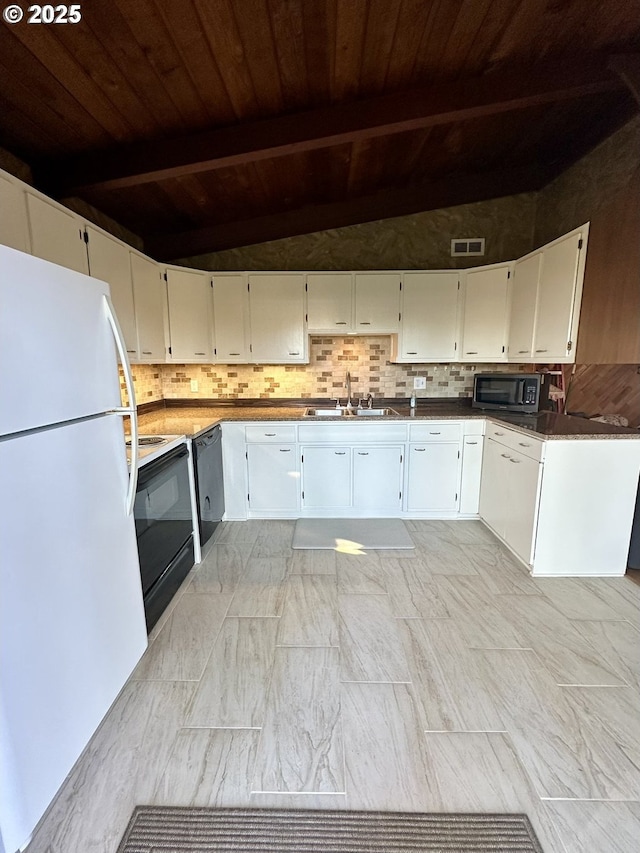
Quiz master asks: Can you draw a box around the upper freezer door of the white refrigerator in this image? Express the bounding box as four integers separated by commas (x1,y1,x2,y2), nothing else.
0,246,121,435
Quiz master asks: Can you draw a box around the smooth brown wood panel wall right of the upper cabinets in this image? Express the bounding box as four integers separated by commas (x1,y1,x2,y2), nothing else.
576,168,640,364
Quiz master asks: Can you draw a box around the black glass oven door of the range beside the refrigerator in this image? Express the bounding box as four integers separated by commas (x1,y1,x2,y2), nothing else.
133,445,193,596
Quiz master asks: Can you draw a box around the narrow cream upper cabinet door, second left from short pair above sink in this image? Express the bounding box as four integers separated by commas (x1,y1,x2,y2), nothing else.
213,273,249,364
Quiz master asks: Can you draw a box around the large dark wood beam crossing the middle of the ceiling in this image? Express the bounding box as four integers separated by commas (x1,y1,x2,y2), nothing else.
34,59,623,197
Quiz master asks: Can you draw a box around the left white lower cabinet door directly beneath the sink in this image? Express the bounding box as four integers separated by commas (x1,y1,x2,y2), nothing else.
302,447,351,509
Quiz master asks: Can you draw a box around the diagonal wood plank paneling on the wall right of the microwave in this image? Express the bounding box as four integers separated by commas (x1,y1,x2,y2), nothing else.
567,364,640,427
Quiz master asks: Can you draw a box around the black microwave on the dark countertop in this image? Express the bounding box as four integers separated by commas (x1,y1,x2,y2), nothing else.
471,373,549,412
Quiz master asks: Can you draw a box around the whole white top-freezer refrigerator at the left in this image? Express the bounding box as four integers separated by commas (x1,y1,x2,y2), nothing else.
0,246,147,853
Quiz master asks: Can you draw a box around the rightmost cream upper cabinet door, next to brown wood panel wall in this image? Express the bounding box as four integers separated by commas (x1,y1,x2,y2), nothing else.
534,233,582,361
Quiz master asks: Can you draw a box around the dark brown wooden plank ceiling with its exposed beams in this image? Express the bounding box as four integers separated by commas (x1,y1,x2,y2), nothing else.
0,0,640,259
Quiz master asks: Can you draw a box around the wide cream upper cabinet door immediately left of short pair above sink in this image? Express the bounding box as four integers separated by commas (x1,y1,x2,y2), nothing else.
249,274,307,364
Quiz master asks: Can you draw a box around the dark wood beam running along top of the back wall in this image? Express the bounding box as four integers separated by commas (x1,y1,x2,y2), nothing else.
145,166,549,261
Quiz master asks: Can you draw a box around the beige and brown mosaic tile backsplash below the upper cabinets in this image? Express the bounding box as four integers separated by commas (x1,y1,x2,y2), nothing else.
122,335,519,403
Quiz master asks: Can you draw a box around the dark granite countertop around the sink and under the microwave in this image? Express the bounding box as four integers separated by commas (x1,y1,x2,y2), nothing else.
132,398,640,440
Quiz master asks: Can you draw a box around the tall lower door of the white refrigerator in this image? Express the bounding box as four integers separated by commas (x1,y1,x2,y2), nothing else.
0,415,147,851
